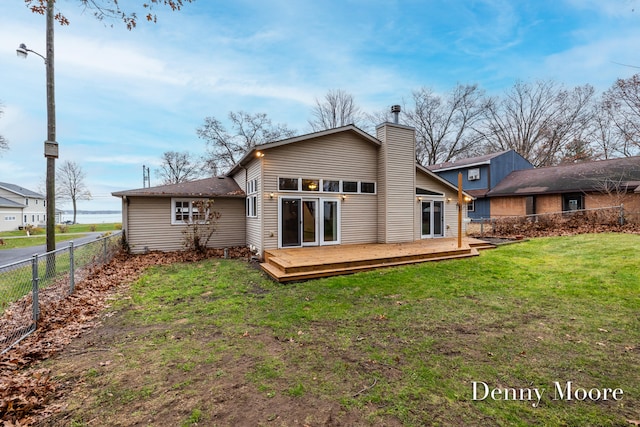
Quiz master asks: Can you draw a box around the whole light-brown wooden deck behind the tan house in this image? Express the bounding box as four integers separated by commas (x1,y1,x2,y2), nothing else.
260,238,495,282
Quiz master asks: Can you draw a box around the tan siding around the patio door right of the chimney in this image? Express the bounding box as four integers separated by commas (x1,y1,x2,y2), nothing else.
414,169,467,239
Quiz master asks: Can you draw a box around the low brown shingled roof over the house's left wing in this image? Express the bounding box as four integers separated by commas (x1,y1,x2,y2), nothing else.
111,176,245,197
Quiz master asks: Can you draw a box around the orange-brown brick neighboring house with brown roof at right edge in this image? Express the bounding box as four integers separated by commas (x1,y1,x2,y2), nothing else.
487,157,640,217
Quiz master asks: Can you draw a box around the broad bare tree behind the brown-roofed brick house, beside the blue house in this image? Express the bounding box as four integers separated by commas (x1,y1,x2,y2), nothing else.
479,81,594,166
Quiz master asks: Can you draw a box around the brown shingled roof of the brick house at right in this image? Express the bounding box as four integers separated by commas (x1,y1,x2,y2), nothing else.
487,156,640,197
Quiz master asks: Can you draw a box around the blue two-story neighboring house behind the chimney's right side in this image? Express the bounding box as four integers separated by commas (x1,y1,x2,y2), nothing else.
427,150,533,220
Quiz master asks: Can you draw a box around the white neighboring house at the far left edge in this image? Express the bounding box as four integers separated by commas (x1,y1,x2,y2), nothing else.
0,182,47,231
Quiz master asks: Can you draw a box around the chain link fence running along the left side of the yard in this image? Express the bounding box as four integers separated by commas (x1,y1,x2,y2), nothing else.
0,232,122,354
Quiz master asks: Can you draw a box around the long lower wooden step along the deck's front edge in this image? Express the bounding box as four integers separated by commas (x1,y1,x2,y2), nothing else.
260,248,479,282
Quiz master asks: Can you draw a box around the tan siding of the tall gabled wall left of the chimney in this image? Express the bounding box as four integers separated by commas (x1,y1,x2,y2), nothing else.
261,132,379,249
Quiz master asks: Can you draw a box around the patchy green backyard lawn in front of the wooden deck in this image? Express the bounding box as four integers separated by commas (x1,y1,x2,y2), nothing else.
42,234,640,426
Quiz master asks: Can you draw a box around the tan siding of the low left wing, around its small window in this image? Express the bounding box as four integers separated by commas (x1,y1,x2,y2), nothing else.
126,197,246,253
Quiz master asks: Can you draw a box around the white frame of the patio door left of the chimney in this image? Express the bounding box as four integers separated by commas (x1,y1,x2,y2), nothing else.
278,196,341,248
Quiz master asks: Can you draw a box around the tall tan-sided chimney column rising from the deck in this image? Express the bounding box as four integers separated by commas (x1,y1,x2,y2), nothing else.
377,123,416,243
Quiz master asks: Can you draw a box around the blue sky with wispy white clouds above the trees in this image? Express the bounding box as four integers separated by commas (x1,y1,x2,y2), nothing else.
0,0,640,209
